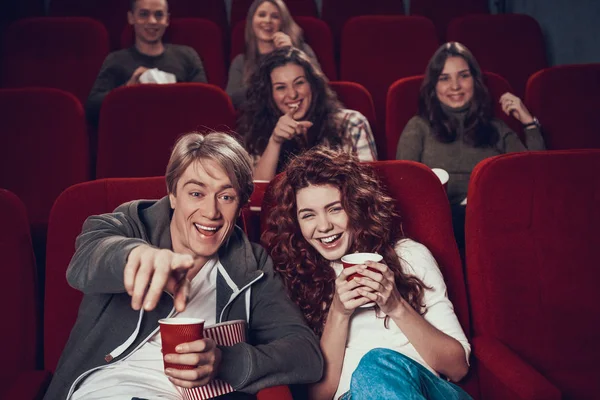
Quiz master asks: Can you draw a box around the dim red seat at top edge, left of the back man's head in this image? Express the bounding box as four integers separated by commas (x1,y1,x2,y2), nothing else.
49,0,129,49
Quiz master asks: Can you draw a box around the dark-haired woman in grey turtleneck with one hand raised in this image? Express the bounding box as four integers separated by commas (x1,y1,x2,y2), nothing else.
396,42,545,204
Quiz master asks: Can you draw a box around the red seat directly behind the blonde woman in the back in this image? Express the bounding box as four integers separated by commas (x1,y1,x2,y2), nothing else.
230,17,337,80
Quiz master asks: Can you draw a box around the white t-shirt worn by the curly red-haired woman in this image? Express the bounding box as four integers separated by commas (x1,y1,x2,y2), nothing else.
331,239,471,399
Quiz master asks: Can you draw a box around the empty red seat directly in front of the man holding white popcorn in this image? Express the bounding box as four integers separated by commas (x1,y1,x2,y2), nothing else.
96,83,235,178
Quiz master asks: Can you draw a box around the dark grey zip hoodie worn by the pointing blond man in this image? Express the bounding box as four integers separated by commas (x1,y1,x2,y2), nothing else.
44,197,323,400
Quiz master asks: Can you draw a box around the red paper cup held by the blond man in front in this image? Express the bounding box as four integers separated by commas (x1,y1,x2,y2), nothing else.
158,318,204,369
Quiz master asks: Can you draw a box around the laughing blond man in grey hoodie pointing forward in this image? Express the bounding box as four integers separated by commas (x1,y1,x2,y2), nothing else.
45,133,323,400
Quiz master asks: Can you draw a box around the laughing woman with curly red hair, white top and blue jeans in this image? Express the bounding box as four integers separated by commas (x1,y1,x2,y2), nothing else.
262,147,470,399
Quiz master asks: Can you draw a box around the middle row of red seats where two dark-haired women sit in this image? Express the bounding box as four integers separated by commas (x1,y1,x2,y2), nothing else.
0,64,600,268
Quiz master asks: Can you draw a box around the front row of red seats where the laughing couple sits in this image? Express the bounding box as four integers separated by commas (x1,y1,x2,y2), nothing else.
0,150,600,400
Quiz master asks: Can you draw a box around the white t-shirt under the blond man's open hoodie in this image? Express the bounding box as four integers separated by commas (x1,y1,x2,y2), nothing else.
71,258,220,400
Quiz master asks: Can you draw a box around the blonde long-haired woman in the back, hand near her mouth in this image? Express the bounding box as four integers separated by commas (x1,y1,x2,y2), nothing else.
226,0,319,108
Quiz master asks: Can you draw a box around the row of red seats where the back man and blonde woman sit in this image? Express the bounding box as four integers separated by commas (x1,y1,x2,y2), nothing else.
0,14,547,111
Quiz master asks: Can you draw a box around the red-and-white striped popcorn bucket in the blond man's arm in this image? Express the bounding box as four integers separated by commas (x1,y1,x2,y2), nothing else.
181,319,246,400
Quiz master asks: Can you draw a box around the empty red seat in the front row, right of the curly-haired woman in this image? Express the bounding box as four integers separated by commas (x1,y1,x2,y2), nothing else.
466,150,600,400
